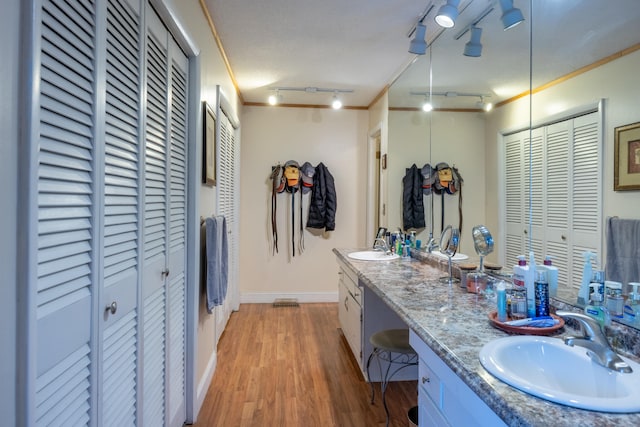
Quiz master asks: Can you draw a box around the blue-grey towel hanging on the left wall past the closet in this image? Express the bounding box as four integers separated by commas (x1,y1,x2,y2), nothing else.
206,216,229,313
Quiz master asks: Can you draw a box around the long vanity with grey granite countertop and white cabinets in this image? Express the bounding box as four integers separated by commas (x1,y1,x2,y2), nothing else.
334,249,640,427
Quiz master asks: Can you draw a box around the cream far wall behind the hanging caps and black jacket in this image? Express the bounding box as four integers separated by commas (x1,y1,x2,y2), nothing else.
238,106,368,302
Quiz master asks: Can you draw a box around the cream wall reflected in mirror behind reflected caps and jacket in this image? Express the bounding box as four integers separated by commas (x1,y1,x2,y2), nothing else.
388,111,491,256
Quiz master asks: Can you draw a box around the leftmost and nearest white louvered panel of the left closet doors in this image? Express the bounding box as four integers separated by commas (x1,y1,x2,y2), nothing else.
34,0,97,427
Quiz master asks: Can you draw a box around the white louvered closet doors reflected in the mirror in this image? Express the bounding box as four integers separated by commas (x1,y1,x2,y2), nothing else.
503,112,602,293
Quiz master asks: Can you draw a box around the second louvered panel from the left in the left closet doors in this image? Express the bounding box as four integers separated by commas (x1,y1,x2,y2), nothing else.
99,0,141,426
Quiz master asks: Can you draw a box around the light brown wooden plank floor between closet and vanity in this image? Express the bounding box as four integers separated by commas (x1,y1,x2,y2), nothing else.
194,303,417,427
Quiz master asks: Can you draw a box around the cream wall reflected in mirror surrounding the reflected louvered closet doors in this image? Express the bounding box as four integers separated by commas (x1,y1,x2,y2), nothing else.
486,51,640,259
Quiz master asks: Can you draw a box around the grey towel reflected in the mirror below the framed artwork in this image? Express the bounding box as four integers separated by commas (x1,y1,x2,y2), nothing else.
606,217,640,286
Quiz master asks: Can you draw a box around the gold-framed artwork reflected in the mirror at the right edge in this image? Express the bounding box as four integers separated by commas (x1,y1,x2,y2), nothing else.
613,122,640,191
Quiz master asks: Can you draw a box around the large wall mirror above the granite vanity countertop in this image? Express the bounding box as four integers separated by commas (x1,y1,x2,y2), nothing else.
386,0,640,328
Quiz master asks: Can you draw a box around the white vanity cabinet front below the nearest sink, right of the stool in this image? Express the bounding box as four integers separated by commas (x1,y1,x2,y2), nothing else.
409,330,506,427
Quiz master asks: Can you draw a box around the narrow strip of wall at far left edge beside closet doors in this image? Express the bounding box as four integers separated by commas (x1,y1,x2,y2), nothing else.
0,0,20,426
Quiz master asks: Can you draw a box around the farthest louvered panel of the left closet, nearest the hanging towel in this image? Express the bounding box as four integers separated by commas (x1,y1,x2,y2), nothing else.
167,39,188,427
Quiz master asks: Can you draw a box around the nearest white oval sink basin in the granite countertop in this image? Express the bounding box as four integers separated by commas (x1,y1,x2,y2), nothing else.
480,335,640,413
